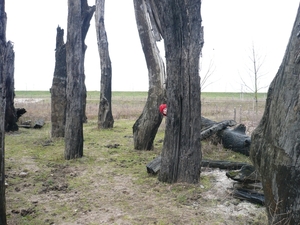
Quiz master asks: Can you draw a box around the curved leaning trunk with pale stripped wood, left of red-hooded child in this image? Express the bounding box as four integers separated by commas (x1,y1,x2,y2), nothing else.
133,0,165,150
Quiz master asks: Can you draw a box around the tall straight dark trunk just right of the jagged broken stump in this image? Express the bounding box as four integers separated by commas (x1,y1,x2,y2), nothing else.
65,0,95,159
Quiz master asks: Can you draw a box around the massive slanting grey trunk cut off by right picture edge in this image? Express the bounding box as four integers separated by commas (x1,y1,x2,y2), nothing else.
250,3,300,225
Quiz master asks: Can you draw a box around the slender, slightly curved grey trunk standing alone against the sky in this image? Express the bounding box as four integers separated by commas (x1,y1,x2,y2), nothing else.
95,0,114,129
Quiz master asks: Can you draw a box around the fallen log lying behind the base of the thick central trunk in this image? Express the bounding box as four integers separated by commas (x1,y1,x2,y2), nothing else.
146,156,248,174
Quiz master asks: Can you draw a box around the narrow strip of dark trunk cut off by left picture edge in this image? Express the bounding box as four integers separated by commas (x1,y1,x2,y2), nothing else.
0,0,7,225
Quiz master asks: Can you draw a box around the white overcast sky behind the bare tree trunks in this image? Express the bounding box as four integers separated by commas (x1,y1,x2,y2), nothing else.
6,0,299,92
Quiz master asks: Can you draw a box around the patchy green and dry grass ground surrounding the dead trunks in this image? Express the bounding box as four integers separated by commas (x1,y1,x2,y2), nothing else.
6,90,266,225
